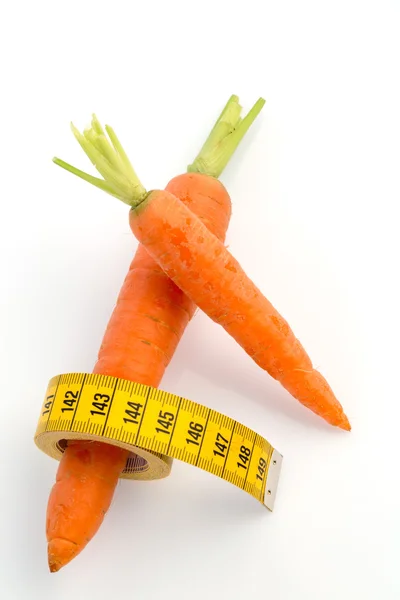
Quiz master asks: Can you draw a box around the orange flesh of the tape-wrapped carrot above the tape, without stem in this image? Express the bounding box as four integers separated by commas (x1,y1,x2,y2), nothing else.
94,173,231,387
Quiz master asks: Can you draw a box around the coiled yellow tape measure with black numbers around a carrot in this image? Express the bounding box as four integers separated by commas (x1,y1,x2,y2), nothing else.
35,373,282,510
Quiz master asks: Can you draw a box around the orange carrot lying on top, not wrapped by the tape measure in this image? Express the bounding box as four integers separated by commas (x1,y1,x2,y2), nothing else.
55,103,350,430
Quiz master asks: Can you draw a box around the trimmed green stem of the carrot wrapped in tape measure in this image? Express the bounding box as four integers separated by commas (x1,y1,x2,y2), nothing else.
188,96,265,178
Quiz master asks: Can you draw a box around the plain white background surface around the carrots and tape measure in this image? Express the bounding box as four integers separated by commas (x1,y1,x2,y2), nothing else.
0,0,400,600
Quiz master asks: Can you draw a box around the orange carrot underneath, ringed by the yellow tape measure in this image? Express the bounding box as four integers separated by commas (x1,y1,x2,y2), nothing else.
46,96,262,571
